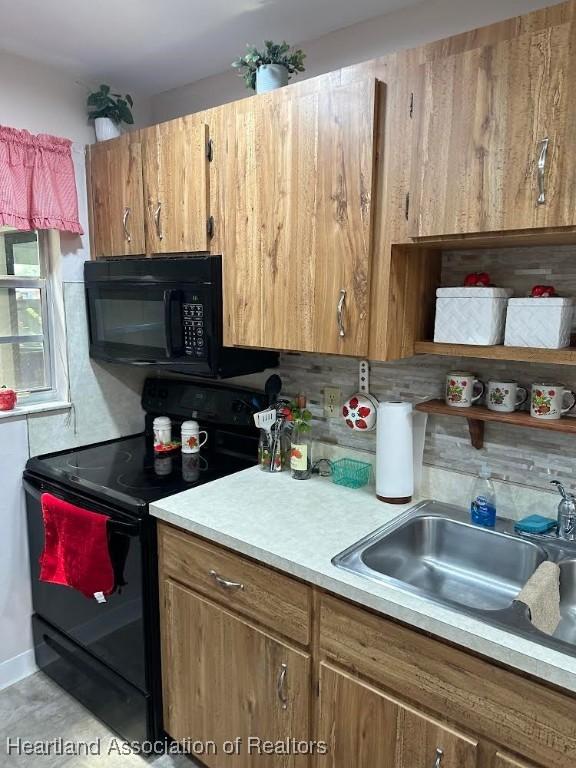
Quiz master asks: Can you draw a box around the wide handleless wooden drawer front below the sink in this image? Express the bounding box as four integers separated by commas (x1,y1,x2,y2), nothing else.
320,598,576,768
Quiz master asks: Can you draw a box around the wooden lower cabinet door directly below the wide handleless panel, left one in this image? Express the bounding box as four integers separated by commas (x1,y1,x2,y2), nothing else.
318,663,478,768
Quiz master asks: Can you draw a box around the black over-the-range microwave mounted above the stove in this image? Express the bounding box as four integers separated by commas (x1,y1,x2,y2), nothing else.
84,255,278,378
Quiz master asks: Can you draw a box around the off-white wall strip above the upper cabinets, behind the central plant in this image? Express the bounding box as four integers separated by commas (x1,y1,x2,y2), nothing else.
152,0,554,122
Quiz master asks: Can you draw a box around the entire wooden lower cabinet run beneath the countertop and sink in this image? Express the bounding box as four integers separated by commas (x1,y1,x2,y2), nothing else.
159,523,576,768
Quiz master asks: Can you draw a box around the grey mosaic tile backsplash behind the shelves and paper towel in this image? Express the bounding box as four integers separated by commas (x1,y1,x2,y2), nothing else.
268,246,576,489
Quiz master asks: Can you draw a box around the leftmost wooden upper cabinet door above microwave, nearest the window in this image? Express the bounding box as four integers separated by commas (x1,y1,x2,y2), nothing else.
86,132,146,259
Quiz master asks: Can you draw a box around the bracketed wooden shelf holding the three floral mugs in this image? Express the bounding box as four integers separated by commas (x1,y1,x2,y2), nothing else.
416,400,576,448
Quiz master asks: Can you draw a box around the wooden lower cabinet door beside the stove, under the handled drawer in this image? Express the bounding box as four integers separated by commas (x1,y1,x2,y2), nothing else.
162,580,310,768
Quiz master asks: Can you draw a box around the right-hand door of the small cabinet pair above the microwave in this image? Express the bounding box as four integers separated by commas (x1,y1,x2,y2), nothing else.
142,115,209,254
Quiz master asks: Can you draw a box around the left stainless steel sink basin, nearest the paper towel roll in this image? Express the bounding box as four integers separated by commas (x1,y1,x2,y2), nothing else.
333,503,548,612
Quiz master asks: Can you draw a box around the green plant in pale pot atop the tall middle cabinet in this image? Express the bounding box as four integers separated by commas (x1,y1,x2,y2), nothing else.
232,40,306,93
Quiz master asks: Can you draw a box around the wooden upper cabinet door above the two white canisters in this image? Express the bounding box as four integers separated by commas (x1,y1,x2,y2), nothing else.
410,22,576,237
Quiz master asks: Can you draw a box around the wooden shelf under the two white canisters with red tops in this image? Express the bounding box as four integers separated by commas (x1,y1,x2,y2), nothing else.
414,341,576,366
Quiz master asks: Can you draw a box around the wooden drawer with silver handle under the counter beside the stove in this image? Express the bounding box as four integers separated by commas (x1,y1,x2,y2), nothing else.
158,523,311,645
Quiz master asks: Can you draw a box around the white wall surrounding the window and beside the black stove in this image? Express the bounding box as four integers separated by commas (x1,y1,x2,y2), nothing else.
0,51,149,689
